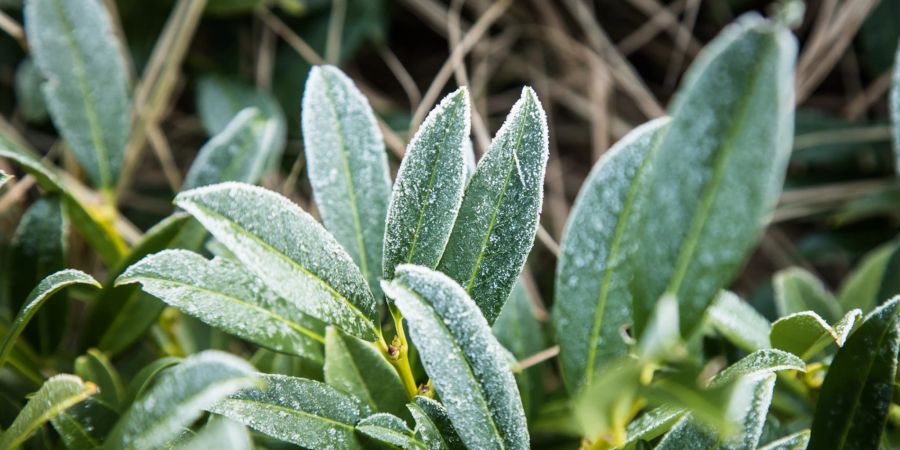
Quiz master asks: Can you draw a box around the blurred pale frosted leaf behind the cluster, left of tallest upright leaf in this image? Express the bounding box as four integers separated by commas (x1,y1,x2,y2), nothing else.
182,108,278,190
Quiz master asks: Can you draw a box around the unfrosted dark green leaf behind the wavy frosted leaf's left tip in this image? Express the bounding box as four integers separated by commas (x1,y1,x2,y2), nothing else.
85,213,190,355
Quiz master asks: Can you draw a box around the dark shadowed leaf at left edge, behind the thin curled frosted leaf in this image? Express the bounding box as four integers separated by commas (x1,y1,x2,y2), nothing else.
0,194,69,354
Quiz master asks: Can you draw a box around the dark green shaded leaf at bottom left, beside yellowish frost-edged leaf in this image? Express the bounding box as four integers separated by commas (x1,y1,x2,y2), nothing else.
50,398,119,450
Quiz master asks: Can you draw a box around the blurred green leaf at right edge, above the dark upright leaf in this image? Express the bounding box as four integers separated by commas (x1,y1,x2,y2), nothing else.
838,242,900,311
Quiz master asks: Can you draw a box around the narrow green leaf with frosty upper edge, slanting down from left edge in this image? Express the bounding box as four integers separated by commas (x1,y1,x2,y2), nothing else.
0,132,125,265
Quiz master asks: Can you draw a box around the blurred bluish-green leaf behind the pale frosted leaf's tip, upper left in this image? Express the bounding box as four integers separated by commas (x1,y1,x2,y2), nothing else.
197,74,287,172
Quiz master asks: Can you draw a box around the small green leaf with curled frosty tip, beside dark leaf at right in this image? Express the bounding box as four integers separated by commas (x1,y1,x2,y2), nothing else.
770,309,862,359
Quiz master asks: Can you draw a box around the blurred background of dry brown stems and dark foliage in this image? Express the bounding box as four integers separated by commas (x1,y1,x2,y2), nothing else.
0,0,900,348
